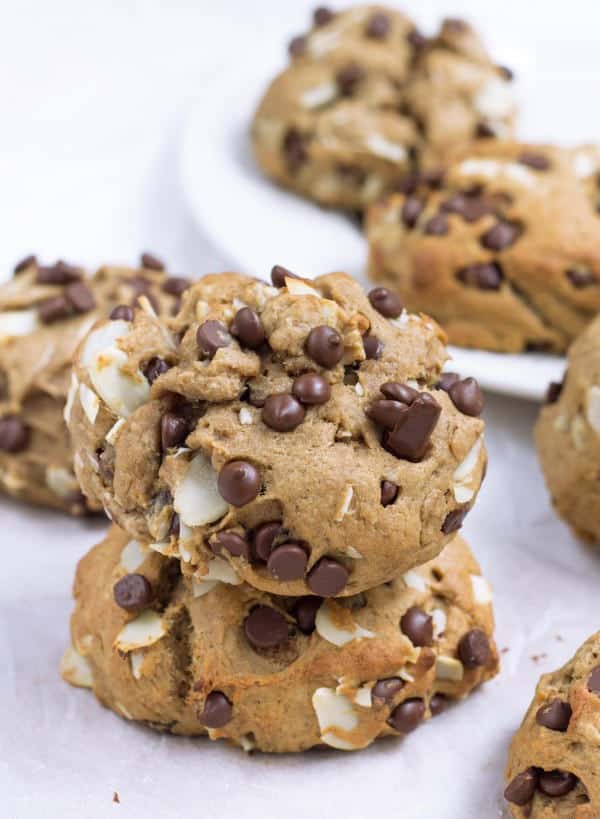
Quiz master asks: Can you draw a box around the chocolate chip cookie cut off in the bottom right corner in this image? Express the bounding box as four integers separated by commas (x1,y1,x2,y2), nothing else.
504,632,600,819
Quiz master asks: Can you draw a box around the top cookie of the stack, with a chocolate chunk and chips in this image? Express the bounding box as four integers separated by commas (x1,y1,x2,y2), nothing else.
70,267,486,596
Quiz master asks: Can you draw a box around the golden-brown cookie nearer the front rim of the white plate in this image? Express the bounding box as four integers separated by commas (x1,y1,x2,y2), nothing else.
366,140,600,353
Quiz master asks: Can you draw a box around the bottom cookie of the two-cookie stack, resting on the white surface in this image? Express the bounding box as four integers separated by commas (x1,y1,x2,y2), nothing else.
61,527,498,752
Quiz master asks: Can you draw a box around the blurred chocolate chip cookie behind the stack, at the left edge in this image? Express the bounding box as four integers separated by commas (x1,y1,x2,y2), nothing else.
0,254,184,515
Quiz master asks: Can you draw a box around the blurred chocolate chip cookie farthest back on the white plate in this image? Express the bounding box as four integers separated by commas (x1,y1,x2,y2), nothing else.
251,6,514,210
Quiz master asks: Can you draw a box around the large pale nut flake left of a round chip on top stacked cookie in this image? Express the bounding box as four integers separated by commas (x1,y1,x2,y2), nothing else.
173,452,229,526
